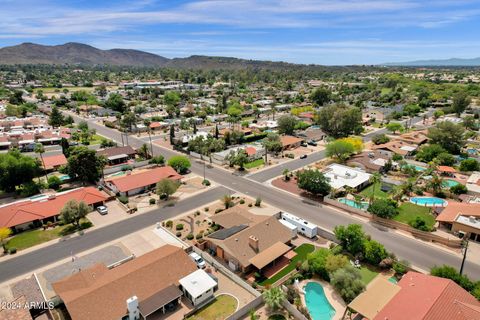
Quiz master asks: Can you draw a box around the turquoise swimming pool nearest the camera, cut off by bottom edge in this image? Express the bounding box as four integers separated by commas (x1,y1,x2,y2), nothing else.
304,282,335,320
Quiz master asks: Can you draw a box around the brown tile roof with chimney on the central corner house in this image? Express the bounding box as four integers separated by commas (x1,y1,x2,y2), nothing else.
210,216,292,267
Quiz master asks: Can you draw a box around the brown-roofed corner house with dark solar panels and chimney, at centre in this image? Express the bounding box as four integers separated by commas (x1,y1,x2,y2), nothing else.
205,207,292,273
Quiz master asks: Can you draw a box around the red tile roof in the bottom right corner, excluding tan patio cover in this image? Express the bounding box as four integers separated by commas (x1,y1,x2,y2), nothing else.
374,271,480,320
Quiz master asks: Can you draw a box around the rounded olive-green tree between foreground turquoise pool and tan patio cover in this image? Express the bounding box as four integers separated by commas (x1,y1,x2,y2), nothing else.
330,266,365,303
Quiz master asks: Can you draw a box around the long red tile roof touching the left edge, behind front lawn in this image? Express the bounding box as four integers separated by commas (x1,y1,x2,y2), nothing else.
0,187,108,227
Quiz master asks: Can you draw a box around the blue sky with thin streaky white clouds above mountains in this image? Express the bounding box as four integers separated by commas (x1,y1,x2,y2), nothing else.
0,0,480,65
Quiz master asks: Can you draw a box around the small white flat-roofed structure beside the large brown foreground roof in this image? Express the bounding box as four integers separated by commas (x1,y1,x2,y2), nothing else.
178,269,217,306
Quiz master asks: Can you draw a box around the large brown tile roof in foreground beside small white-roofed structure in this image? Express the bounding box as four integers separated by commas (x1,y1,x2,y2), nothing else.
53,245,197,320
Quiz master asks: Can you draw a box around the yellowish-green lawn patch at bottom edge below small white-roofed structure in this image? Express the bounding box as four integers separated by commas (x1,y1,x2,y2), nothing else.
187,294,238,320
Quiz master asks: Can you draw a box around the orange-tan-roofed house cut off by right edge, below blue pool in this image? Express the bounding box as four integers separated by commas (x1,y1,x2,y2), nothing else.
436,201,480,242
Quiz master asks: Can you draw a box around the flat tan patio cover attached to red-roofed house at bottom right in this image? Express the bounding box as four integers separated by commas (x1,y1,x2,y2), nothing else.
348,276,401,319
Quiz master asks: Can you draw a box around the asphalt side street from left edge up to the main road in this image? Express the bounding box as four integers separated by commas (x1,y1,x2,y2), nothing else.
0,187,231,283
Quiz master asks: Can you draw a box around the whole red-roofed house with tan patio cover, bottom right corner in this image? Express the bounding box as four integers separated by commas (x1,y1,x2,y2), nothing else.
348,271,480,320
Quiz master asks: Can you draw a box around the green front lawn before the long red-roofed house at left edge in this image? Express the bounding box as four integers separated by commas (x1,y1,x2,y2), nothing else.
5,219,91,250
